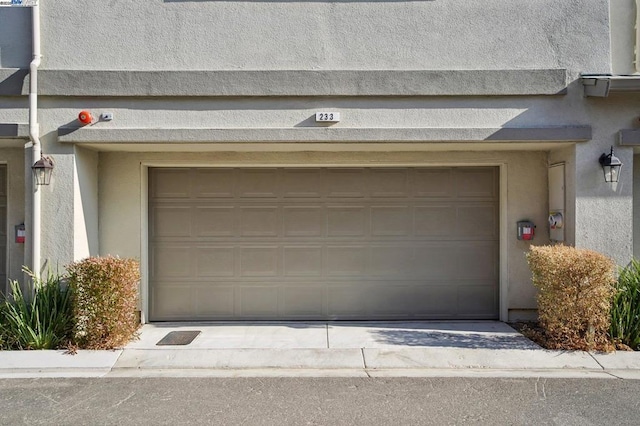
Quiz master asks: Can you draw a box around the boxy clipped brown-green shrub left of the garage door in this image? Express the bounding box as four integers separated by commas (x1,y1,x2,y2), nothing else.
67,256,140,349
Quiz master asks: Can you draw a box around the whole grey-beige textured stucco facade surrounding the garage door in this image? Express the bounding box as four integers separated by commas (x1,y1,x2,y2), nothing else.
0,0,640,320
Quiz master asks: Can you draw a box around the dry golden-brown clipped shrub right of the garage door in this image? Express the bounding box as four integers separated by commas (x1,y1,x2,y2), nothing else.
527,246,615,351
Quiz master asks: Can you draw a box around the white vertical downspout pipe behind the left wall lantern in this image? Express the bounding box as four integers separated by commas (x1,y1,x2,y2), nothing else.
29,5,42,277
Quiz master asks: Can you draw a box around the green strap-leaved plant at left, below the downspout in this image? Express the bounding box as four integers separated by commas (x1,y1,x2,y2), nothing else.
0,270,73,349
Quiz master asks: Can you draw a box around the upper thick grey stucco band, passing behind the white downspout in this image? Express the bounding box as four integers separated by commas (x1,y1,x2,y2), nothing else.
0,68,567,97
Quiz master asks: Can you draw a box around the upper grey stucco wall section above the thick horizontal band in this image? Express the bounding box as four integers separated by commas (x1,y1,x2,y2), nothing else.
28,0,610,72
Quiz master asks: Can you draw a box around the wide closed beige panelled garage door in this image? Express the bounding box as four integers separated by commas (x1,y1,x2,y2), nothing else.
149,167,498,321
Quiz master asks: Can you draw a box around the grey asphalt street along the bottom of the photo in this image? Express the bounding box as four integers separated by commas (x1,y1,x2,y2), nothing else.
0,378,640,425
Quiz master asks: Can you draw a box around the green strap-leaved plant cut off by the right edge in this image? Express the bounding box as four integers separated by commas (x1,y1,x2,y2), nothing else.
610,259,640,351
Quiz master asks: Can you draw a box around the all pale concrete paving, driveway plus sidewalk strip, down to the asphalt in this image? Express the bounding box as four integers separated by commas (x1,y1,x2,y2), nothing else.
0,321,640,379
